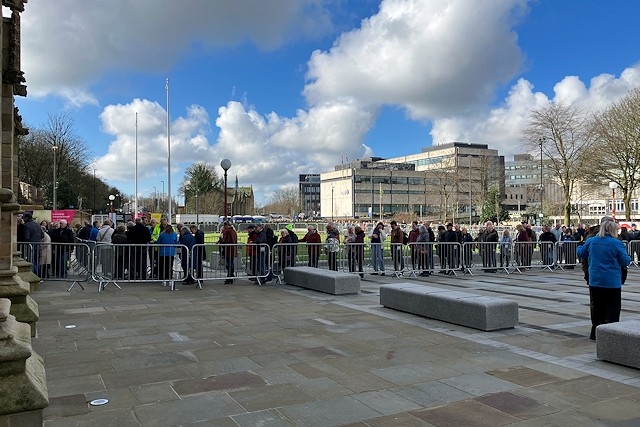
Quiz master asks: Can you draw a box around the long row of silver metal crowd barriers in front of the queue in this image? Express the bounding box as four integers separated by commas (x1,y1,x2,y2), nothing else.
18,236,640,291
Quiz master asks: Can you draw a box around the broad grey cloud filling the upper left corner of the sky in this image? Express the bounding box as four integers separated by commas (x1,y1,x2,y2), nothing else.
22,0,332,105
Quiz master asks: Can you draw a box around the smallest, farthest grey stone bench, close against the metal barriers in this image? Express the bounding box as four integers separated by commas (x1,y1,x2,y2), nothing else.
284,267,360,295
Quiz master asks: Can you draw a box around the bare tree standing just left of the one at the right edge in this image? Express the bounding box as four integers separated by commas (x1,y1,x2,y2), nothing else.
523,102,589,224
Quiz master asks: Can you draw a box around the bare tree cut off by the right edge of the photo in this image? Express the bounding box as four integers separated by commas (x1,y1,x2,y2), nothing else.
585,88,640,221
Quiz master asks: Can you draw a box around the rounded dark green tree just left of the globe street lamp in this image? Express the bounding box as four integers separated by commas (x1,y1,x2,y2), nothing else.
178,162,224,213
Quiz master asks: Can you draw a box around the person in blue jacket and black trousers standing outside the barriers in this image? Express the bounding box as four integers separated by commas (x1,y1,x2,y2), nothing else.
578,221,631,340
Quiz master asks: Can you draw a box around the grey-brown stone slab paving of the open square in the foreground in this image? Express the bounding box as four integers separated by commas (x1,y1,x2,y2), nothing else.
33,269,640,427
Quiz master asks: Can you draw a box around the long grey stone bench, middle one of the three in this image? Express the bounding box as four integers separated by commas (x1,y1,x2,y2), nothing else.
380,283,518,331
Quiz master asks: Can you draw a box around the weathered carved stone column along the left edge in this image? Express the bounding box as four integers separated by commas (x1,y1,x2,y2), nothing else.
0,0,49,426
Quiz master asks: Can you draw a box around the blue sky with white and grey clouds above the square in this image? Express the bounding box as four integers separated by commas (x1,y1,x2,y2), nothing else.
8,0,640,206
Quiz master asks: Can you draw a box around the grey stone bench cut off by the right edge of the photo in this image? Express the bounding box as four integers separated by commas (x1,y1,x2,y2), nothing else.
596,320,640,369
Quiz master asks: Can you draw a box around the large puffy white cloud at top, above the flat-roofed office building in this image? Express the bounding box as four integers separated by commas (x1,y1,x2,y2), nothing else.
304,0,525,116
